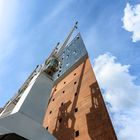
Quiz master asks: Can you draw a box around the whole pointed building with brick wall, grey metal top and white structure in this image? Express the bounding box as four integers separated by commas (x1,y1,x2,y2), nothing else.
0,23,117,140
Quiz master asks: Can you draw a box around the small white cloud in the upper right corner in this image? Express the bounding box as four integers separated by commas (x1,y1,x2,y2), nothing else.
122,3,140,42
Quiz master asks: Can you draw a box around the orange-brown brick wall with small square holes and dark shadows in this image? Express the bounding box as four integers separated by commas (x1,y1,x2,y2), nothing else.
43,59,117,140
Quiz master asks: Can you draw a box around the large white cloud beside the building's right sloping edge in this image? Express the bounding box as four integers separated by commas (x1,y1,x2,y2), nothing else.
94,53,140,140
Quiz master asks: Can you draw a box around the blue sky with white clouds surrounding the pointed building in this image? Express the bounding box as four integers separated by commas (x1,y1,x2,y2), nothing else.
0,0,140,140
